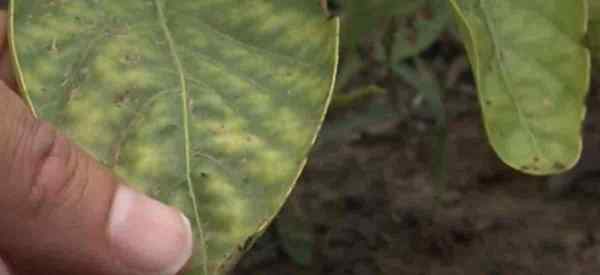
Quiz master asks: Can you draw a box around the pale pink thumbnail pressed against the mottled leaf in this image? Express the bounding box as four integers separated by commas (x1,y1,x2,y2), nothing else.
108,186,192,275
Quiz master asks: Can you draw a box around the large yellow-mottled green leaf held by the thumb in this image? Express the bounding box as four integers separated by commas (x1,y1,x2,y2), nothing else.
11,0,339,274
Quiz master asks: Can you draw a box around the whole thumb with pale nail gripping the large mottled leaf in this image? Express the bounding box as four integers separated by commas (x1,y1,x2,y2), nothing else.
0,84,192,275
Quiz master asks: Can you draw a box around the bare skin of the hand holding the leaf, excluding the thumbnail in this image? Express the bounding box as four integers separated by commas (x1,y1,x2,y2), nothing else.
0,7,190,275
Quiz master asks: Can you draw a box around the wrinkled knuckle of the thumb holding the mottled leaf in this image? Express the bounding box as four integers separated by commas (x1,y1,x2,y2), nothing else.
27,122,87,216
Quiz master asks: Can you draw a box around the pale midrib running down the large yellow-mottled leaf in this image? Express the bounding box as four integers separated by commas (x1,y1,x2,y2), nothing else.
154,0,208,275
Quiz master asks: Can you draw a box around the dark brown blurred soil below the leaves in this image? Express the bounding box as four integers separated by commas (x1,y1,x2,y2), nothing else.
235,40,600,275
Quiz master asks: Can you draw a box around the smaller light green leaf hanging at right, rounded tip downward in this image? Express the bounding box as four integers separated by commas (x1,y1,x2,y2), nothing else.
450,0,590,175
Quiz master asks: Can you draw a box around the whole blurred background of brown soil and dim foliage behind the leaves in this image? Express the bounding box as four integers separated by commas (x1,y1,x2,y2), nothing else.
234,0,600,275
